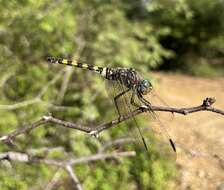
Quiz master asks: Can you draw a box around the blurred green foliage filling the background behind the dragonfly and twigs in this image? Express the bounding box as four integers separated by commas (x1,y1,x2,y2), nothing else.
0,0,224,190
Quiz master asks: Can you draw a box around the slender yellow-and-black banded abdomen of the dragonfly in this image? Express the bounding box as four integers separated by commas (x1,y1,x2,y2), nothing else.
47,57,106,76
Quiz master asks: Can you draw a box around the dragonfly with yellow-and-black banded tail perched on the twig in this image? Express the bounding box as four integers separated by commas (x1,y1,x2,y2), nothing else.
47,57,176,152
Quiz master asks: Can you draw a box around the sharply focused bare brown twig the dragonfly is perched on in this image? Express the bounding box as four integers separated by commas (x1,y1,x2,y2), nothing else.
0,98,224,142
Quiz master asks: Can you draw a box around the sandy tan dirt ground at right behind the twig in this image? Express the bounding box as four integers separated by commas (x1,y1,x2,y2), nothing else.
148,73,224,190
